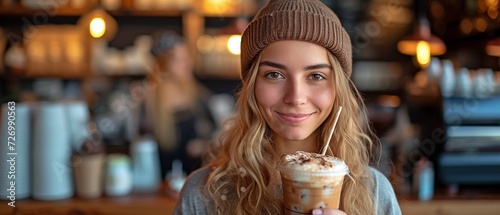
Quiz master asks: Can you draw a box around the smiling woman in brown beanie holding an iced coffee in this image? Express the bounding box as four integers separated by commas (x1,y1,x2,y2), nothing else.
176,0,401,215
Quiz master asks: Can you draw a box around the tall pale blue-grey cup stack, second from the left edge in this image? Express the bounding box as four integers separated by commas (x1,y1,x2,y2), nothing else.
33,102,74,200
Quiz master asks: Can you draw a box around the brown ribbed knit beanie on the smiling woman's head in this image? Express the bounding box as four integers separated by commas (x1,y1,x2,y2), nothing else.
240,0,352,79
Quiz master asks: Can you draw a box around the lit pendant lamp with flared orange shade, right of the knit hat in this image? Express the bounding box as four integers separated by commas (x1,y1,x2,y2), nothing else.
397,0,446,67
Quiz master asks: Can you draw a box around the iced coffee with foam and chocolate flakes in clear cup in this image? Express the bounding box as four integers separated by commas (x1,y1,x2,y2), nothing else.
278,151,349,214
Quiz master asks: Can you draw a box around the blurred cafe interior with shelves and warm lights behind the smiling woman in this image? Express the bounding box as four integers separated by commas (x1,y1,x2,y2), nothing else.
0,0,500,215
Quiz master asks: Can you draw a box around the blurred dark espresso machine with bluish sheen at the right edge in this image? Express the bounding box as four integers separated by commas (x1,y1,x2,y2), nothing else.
438,95,500,186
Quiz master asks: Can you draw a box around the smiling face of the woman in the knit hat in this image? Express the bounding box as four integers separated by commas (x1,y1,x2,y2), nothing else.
255,40,335,142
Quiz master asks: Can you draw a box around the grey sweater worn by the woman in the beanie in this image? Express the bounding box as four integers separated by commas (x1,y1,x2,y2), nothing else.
174,168,401,215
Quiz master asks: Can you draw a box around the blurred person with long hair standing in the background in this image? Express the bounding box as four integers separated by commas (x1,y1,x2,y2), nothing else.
145,31,215,176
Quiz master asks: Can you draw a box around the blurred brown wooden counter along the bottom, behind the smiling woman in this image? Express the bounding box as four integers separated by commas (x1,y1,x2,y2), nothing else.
0,185,500,215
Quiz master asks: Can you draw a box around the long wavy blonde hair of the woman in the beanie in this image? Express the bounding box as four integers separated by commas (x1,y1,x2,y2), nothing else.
204,52,378,214
